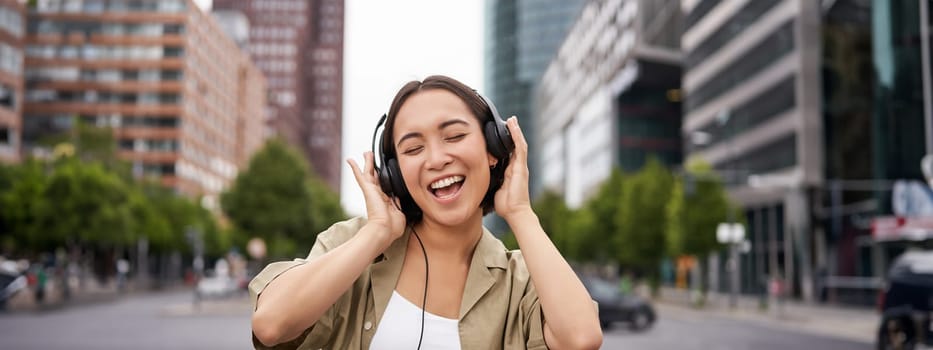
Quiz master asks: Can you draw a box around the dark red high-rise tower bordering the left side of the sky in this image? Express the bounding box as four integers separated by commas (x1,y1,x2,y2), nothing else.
213,0,344,192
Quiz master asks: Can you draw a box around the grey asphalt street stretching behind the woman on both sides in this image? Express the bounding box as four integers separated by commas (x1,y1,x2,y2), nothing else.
0,292,872,350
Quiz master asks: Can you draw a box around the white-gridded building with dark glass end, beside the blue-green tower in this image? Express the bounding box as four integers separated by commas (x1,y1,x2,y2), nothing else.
533,0,682,207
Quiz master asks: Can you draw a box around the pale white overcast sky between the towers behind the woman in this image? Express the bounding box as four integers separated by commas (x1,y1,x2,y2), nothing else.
194,0,485,216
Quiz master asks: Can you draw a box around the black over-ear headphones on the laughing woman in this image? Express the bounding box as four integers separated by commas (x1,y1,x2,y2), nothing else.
371,90,515,205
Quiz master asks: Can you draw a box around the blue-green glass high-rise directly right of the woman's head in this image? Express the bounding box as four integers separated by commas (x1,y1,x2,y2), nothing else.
484,0,585,197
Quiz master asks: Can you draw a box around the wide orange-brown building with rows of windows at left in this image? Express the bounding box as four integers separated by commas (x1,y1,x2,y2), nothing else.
23,0,266,208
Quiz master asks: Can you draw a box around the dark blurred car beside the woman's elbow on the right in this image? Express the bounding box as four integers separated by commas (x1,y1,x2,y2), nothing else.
580,276,656,331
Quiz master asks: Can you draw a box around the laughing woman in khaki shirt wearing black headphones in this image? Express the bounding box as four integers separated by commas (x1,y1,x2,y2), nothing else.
250,76,602,349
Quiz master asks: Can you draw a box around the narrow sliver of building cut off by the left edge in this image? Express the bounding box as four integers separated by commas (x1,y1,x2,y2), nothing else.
0,0,26,163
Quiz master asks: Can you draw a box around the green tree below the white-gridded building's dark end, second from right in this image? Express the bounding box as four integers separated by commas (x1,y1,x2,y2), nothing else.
613,157,674,281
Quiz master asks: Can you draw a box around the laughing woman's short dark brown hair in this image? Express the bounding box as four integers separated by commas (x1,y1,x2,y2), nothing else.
380,75,508,225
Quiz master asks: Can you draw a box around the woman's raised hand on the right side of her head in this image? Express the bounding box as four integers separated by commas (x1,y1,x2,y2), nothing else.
495,116,531,222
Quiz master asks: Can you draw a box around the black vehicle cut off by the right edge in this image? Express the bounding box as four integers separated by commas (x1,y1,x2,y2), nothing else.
877,251,933,350
